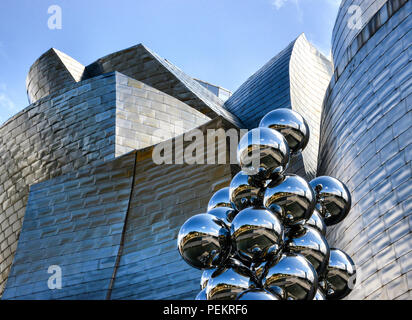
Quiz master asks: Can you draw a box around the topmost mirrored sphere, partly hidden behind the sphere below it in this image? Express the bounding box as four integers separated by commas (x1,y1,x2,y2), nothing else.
259,108,309,153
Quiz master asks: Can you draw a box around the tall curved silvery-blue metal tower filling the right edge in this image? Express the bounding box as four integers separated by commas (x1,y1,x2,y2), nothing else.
318,1,412,299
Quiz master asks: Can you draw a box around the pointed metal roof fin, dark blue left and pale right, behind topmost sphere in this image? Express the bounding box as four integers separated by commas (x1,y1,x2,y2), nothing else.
225,34,332,177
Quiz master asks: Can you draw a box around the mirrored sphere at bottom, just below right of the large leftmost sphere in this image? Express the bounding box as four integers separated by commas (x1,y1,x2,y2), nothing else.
206,268,254,300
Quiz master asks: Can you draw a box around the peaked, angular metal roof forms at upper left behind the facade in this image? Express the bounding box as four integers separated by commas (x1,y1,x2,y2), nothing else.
26,44,243,127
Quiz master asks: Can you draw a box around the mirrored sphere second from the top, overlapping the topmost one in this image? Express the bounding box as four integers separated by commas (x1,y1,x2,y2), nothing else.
237,128,290,180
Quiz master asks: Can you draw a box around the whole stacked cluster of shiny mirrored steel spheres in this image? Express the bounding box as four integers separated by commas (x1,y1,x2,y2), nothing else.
177,109,356,300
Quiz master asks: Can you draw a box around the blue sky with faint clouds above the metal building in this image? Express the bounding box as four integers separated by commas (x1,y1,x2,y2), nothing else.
0,0,340,123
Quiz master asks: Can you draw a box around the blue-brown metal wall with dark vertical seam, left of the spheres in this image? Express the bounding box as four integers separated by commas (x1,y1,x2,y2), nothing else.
3,117,238,299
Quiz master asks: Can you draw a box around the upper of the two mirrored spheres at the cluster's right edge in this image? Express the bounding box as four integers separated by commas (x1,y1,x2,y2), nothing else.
309,176,352,226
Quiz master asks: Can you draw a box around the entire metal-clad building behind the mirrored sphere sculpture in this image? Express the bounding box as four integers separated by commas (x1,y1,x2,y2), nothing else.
0,0,412,299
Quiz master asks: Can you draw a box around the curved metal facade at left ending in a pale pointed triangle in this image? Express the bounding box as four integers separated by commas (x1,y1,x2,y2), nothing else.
0,66,210,293
